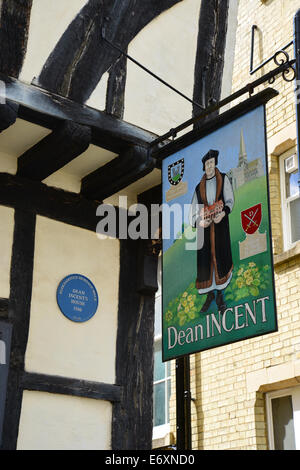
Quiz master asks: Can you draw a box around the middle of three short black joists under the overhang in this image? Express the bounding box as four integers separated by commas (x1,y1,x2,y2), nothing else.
17,121,91,181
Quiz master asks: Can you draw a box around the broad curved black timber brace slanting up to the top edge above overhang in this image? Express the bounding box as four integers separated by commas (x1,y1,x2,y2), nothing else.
38,0,182,103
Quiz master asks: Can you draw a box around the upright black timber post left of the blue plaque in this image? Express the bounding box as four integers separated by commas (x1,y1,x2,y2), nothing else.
2,210,36,450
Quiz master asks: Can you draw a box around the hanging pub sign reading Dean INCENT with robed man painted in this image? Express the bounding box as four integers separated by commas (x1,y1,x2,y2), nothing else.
162,104,277,360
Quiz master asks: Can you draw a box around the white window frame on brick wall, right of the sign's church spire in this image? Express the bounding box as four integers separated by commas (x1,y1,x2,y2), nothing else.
279,147,300,251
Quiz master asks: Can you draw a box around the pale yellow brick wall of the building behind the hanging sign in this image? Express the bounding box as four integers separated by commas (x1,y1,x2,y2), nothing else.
170,0,300,450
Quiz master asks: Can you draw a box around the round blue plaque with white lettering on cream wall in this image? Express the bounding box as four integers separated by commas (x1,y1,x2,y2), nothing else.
56,274,98,323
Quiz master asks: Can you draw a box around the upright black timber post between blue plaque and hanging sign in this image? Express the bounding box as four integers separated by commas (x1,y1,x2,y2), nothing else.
112,240,154,450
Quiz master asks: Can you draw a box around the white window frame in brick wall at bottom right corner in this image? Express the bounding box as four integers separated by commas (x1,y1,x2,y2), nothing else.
266,386,300,450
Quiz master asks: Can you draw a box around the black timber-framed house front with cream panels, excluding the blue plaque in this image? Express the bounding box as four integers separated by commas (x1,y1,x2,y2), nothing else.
0,0,233,449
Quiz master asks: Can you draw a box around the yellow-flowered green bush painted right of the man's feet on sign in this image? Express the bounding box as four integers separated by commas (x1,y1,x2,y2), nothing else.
225,261,270,301
